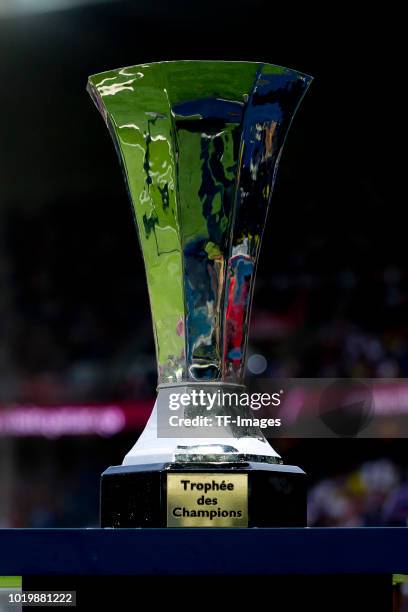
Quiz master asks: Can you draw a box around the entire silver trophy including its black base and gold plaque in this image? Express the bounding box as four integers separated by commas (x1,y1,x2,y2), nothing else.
88,61,312,527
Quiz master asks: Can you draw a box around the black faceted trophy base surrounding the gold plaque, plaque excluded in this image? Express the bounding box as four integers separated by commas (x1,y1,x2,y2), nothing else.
101,462,306,528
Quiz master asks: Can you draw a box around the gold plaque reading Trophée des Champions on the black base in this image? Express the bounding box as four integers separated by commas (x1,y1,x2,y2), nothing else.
167,472,248,527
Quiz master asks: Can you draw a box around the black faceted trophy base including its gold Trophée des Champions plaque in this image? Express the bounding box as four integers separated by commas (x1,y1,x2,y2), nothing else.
101,462,306,528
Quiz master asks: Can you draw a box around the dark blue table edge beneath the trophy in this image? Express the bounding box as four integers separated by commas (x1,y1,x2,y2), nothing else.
0,527,408,576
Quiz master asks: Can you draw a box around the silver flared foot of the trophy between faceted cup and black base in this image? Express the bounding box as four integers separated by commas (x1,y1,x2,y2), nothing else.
123,383,281,465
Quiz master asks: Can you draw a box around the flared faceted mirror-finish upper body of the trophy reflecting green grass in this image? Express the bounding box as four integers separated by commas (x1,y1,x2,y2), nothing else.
88,61,311,385
